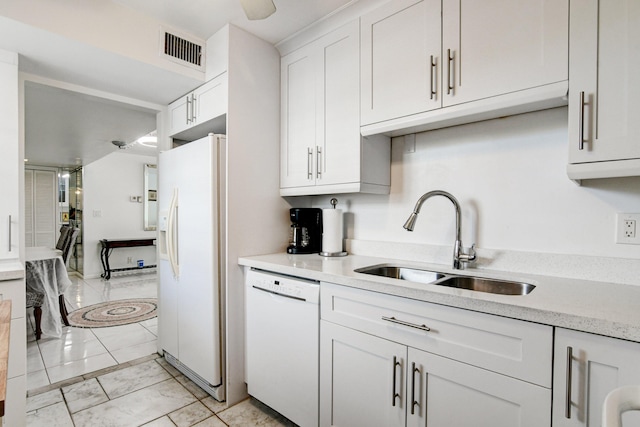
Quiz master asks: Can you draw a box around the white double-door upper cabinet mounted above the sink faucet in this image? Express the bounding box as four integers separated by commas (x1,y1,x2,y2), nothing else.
361,0,569,135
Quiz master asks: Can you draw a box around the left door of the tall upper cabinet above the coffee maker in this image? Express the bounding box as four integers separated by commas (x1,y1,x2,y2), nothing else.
280,45,320,188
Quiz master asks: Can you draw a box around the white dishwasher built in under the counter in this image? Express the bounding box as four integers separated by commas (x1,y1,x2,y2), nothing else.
245,269,320,427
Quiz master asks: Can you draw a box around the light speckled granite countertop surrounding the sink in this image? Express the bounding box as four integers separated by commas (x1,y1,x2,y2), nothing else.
238,253,640,342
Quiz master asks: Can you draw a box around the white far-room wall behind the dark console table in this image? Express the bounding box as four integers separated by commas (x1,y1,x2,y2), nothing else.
83,152,156,278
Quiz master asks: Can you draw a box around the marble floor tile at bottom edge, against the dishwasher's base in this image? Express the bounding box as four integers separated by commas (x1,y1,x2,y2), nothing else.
216,398,296,427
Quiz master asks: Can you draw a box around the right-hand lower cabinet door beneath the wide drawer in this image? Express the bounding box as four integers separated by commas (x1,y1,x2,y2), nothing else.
407,348,551,427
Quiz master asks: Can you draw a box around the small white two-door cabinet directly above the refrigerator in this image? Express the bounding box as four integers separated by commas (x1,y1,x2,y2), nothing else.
168,73,228,136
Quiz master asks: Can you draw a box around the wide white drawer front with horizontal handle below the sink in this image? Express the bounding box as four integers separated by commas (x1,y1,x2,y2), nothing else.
320,282,553,388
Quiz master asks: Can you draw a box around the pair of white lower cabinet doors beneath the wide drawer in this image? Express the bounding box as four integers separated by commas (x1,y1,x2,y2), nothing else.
320,321,551,427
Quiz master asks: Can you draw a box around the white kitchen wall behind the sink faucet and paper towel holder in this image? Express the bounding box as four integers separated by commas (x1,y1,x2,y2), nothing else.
313,108,640,259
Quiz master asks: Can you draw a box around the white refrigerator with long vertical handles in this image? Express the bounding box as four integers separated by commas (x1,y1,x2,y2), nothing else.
158,134,226,401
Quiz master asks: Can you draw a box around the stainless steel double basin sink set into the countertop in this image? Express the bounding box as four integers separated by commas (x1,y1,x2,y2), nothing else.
354,264,535,295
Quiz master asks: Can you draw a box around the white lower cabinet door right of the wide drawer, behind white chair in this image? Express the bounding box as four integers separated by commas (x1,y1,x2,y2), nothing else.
553,328,640,427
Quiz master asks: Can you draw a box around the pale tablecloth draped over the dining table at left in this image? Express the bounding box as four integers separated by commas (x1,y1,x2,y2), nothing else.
25,247,71,338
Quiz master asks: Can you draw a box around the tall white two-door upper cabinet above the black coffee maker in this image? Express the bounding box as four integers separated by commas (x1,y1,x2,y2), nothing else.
280,21,391,196
